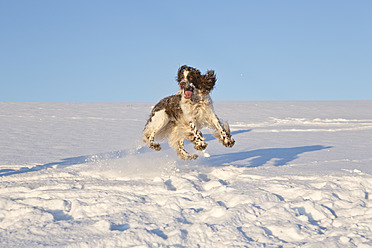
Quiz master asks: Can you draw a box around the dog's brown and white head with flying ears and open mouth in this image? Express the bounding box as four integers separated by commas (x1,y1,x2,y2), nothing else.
177,65,216,99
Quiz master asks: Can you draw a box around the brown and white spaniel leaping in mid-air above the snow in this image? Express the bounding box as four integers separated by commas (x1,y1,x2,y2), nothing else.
142,65,235,161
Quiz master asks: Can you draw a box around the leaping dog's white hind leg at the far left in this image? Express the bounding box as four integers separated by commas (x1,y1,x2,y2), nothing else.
142,109,169,151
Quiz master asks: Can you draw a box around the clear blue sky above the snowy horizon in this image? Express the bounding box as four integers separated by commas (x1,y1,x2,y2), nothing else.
0,0,372,102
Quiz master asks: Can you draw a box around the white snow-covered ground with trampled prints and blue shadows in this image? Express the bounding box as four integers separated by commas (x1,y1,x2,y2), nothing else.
0,101,372,247
